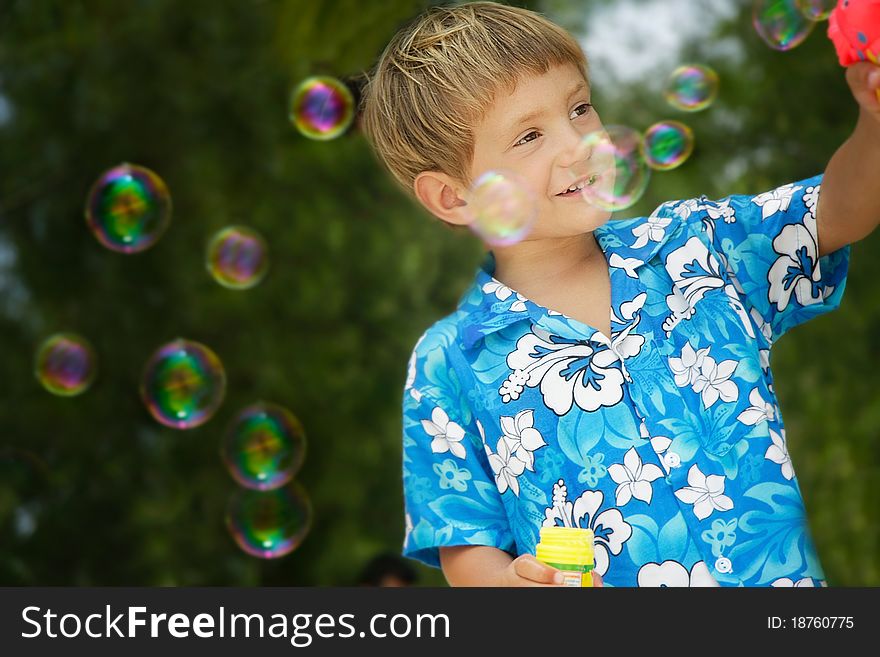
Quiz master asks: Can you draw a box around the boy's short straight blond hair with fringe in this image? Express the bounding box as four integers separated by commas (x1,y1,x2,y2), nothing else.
361,2,588,196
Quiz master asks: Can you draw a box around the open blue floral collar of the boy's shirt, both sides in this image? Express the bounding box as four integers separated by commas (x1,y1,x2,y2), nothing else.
458,212,682,349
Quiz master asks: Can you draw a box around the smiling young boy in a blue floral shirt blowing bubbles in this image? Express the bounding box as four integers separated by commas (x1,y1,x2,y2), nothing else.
363,2,880,586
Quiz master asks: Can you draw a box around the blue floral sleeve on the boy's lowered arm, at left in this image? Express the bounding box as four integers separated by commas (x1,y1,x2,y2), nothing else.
403,387,514,568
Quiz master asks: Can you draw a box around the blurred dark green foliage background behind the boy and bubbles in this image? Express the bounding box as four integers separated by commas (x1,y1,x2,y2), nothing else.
0,0,880,586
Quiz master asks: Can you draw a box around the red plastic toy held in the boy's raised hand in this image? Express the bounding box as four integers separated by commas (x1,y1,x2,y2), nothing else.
828,0,880,66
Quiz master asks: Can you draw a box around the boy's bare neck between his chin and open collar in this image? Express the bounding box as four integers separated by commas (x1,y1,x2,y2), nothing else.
493,232,607,297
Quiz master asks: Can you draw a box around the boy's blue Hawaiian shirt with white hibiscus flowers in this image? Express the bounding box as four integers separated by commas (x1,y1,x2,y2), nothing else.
403,176,850,586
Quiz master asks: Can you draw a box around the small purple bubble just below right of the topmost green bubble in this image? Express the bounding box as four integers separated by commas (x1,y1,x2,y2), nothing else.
205,226,269,290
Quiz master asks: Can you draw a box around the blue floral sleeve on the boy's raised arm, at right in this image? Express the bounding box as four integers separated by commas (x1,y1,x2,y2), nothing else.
661,176,850,344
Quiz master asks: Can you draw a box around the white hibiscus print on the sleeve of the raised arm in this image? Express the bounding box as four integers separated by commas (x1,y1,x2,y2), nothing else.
767,212,833,311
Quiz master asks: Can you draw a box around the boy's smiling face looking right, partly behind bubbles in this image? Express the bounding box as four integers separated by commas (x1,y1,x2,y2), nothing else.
471,64,611,241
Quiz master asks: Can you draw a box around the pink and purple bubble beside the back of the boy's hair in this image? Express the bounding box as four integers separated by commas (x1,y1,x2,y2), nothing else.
290,76,355,140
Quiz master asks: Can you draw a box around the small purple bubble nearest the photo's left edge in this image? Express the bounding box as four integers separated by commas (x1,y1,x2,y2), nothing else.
34,333,97,397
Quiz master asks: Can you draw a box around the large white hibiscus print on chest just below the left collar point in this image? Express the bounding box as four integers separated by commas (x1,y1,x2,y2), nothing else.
498,326,624,415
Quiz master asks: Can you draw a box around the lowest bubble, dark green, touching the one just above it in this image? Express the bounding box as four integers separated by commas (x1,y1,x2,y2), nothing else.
226,482,312,559
